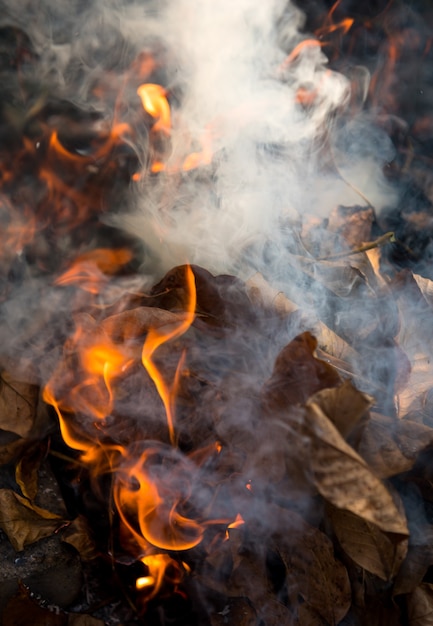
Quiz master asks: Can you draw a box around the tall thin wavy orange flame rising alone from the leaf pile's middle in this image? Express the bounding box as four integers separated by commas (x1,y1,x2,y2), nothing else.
142,265,197,445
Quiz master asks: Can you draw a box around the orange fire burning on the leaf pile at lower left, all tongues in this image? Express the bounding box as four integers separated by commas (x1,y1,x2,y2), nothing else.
44,260,208,596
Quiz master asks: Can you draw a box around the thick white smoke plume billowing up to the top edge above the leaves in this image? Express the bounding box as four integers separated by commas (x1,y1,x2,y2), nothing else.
122,0,396,275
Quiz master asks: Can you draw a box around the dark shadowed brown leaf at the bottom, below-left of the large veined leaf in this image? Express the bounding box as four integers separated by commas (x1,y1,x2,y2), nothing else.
277,511,351,624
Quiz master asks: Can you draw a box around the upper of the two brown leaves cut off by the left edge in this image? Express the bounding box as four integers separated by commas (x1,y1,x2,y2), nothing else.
0,372,39,437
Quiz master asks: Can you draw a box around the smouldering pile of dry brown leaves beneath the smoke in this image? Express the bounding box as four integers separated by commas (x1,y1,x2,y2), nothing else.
0,207,433,626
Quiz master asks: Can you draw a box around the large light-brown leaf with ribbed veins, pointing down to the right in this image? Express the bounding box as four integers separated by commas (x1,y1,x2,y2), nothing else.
306,403,409,536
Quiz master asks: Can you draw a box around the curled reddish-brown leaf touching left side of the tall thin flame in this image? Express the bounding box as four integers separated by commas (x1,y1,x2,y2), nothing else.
100,306,189,341
